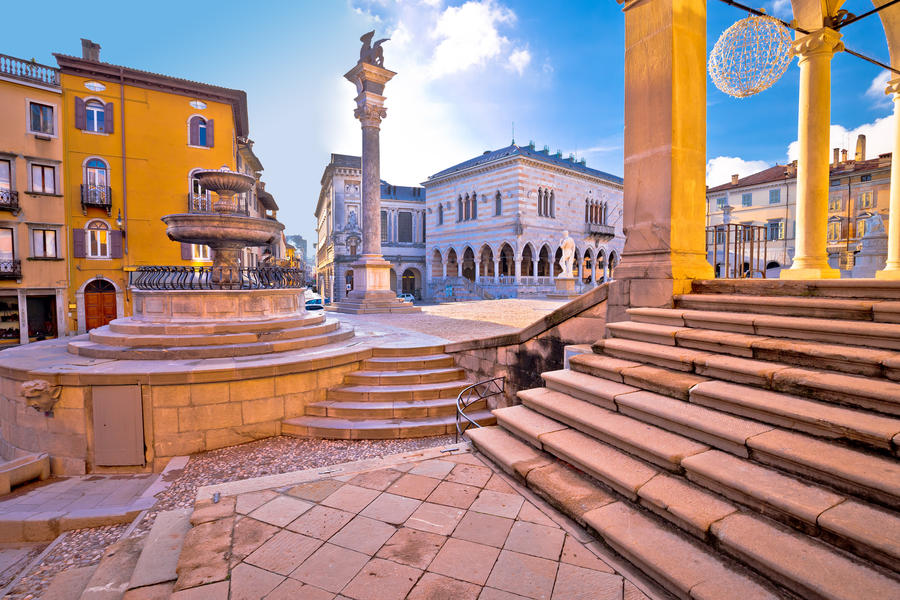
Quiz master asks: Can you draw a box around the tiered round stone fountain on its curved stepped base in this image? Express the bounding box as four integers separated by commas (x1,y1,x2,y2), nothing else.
69,167,353,359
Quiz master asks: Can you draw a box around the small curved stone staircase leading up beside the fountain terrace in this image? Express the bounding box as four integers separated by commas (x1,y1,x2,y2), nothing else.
282,346,494,440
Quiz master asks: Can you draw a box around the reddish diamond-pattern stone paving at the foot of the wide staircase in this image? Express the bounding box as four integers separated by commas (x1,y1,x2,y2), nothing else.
173,444,650,600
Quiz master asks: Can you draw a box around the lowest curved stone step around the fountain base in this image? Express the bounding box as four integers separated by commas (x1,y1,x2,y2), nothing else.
68,325,353,360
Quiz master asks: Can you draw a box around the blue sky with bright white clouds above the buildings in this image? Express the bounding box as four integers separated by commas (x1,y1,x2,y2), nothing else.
0,0,893,246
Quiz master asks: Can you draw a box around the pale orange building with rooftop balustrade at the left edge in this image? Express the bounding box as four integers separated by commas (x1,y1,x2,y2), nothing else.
0,55,67,348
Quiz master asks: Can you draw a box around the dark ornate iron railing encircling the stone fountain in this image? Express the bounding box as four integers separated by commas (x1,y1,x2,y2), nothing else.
131,266,306,291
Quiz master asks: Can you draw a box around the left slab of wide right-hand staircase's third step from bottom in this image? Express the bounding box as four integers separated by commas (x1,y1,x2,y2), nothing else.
518,388,709,472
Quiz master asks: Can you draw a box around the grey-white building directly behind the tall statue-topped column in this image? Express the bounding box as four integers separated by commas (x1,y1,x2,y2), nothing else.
315,154,425,302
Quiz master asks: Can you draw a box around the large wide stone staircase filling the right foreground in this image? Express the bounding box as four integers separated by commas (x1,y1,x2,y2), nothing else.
468,285,900,599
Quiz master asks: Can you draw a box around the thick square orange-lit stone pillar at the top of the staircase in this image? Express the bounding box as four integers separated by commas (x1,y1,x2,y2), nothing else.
608,0,712,310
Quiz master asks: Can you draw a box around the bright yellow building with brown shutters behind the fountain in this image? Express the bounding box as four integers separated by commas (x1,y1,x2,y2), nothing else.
54,40,262,333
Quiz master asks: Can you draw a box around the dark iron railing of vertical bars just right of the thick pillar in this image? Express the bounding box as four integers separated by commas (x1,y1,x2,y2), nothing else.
706,223,769,279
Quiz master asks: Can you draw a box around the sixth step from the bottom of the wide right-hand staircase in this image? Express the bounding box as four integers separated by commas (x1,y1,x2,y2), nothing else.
593,338,900,414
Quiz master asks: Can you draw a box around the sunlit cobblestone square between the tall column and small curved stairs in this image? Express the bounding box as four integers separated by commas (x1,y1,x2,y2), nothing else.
329,298,565,342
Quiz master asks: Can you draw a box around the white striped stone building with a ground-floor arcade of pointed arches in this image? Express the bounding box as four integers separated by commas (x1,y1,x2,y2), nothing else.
422,143,624,300
